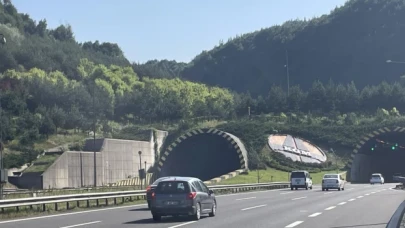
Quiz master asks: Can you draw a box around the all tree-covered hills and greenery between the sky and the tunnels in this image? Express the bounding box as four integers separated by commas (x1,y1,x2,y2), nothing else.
0,0,405,176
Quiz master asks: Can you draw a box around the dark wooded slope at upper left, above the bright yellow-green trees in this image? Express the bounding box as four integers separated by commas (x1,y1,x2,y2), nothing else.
0,0,130,79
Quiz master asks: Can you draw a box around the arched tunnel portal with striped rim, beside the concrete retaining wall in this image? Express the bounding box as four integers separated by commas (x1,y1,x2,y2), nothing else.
155,129,248,181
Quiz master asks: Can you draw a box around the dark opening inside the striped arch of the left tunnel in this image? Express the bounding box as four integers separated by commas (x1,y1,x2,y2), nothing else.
160,133,241,181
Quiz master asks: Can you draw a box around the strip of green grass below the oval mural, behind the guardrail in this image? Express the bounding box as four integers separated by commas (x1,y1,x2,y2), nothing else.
218,168,346,185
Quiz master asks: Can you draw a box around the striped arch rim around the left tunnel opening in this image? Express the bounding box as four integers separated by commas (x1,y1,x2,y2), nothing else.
154,128,248,179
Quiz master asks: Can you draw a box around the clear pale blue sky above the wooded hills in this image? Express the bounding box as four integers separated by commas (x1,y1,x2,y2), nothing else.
12,0,346,63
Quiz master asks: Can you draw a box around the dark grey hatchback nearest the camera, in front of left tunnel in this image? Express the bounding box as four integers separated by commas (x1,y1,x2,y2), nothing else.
151,177,217,221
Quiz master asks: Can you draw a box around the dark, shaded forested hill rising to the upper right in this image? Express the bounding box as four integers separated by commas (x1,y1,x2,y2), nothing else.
181,0,405,95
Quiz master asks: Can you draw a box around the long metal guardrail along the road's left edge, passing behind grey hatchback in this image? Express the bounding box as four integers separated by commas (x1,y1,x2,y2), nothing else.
0,182,290,212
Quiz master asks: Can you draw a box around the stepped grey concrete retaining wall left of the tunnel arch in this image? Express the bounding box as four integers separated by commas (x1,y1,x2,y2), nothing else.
9,130,168,189
